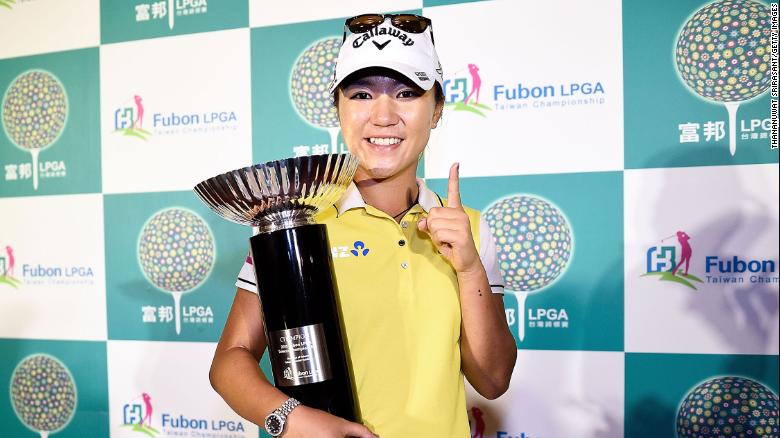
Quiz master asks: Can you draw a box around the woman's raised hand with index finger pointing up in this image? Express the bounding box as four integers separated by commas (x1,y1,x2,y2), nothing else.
417,163,482,273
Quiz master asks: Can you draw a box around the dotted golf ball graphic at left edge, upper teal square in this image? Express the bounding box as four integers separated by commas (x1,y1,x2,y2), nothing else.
3,70,68,150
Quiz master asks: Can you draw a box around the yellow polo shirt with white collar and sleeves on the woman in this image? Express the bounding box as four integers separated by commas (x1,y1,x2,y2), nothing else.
236,180,503,438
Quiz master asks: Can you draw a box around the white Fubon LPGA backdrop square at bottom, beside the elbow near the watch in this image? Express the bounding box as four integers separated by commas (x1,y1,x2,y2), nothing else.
107,341,258,438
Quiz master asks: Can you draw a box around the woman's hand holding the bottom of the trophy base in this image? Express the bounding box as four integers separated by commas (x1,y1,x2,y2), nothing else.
281,405,379,438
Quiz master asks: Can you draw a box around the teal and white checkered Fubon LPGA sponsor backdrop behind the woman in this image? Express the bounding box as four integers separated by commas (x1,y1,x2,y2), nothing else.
0,0,780,438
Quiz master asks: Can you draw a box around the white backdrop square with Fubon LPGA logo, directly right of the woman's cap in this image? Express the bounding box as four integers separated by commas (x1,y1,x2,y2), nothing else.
425,0,623,178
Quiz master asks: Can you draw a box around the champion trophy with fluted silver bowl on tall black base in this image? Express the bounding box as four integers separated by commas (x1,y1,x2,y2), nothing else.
194,154,358,421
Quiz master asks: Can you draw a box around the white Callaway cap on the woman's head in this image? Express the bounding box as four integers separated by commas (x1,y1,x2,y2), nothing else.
330,17,444,93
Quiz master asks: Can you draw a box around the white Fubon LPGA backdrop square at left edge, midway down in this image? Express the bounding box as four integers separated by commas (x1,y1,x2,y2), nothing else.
0,194,106,340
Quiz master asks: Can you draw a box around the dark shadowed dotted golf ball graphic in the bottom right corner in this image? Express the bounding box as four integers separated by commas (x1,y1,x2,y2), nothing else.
677,377,780,438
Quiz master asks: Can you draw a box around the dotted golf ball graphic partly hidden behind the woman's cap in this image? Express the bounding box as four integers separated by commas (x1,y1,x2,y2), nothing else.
290,38,341,128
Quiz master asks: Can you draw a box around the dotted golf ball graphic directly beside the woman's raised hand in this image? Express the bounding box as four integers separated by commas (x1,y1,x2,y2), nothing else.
484,195,573,292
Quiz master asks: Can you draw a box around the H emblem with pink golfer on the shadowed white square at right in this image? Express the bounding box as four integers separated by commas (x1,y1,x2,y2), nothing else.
642,231,703,290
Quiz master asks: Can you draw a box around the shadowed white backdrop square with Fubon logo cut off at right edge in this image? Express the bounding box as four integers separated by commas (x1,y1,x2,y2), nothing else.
625,164,780,354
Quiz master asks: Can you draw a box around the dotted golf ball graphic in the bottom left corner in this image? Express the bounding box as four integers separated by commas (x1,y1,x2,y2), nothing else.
11,354,77,437
